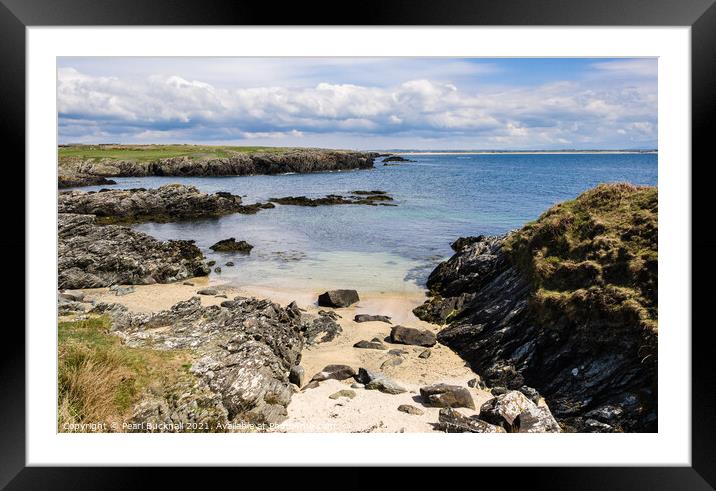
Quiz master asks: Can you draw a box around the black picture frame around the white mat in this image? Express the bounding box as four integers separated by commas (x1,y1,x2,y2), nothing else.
7,0,716,490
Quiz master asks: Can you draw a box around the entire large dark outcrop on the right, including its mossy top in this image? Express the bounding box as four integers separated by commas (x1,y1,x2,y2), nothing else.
414,184,657,432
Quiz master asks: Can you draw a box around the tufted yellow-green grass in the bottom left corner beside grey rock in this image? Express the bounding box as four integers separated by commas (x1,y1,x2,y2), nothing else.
57,316,190,431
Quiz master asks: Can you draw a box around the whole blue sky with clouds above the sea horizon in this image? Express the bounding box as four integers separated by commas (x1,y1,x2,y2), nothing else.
57,57,657,150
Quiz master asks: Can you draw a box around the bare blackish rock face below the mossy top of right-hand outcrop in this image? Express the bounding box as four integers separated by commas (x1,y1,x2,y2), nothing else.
414,230,656,431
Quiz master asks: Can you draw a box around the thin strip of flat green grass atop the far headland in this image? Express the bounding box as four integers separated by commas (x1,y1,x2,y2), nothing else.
58,144,328,162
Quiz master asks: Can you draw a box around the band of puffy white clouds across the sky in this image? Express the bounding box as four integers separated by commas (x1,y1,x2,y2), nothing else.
57,60,657,148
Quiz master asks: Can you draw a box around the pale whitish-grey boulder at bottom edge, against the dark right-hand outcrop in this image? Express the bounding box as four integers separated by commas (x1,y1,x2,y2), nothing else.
480,390,560,433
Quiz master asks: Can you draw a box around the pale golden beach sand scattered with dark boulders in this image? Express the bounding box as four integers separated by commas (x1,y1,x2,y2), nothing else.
78,278,492,432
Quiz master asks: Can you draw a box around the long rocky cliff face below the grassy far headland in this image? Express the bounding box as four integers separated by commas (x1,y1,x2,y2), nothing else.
59,150,377,183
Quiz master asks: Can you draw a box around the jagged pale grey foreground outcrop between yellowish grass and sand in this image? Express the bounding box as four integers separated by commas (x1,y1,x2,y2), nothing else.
107,297,303,423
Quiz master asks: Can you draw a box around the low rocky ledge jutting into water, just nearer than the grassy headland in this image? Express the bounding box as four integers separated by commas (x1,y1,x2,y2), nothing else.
57,184,273,223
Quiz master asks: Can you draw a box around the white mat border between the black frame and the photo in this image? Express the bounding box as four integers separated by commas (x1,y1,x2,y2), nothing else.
26,27,691,465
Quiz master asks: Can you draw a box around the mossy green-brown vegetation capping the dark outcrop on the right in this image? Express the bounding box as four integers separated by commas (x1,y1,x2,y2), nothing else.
504,183,658,336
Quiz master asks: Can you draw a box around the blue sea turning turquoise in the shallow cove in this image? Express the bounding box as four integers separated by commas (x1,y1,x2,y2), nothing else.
75,154,657,293
